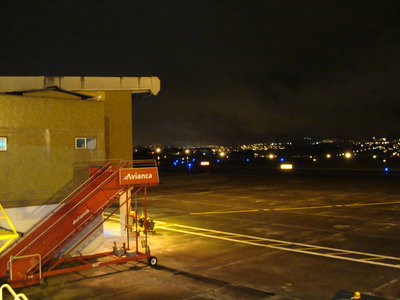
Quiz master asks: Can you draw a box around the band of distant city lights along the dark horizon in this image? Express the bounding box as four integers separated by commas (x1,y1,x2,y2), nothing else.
136,137,400,172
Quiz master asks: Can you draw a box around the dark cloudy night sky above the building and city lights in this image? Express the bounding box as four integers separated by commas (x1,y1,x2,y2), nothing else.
0,0,400,145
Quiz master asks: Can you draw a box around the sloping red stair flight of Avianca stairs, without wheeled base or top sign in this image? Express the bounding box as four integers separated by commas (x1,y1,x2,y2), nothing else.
0,162,159,287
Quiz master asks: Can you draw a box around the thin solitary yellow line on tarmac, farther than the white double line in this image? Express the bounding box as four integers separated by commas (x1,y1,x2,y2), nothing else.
189,201,400,215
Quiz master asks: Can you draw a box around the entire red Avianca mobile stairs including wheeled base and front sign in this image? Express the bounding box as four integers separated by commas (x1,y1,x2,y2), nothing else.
0,160,159,287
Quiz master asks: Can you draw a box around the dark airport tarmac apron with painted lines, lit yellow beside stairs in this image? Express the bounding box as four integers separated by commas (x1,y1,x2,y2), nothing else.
5,172,400,300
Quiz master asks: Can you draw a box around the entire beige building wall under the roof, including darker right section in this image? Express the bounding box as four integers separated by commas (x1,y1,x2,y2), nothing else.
0,91,132,207
